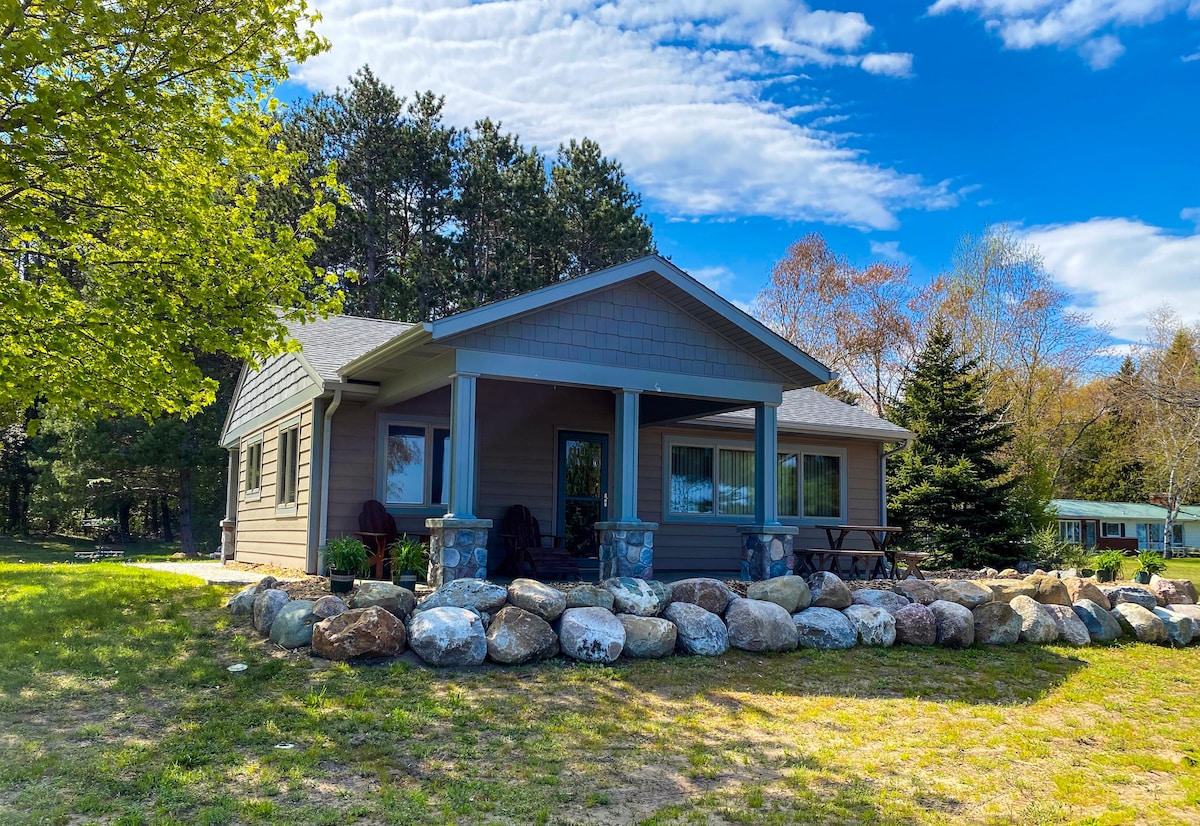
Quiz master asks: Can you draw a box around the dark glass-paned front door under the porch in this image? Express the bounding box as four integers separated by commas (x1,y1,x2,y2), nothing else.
558,431,608,557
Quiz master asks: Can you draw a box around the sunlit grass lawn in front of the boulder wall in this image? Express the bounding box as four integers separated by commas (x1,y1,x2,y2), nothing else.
0,563,1200,826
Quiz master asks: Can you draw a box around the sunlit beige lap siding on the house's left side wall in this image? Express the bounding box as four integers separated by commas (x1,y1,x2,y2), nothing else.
236,402,313,570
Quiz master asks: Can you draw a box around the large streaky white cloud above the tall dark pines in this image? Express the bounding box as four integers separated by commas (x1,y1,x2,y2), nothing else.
296,0,958,228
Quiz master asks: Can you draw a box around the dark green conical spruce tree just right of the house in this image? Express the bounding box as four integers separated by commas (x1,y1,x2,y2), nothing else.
888,319,1022,568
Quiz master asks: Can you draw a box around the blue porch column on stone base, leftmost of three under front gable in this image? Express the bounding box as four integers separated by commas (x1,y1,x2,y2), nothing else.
425,373,492,588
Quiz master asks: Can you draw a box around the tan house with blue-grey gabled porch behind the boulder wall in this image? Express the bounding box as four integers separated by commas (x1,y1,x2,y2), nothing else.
221,256,912,582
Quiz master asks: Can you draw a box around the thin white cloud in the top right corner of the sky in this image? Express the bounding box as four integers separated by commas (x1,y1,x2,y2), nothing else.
929,0,1200,70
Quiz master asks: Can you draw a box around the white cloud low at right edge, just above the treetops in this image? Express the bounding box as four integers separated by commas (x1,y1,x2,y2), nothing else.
1025,219,1200,341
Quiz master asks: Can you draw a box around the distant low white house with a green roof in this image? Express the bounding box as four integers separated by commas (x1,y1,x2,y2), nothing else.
1050,499,1200,551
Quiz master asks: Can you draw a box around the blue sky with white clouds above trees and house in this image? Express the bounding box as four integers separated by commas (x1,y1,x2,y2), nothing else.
284,0,1200,342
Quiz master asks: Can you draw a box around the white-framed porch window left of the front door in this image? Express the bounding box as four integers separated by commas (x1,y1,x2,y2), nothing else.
380,423,450,507
